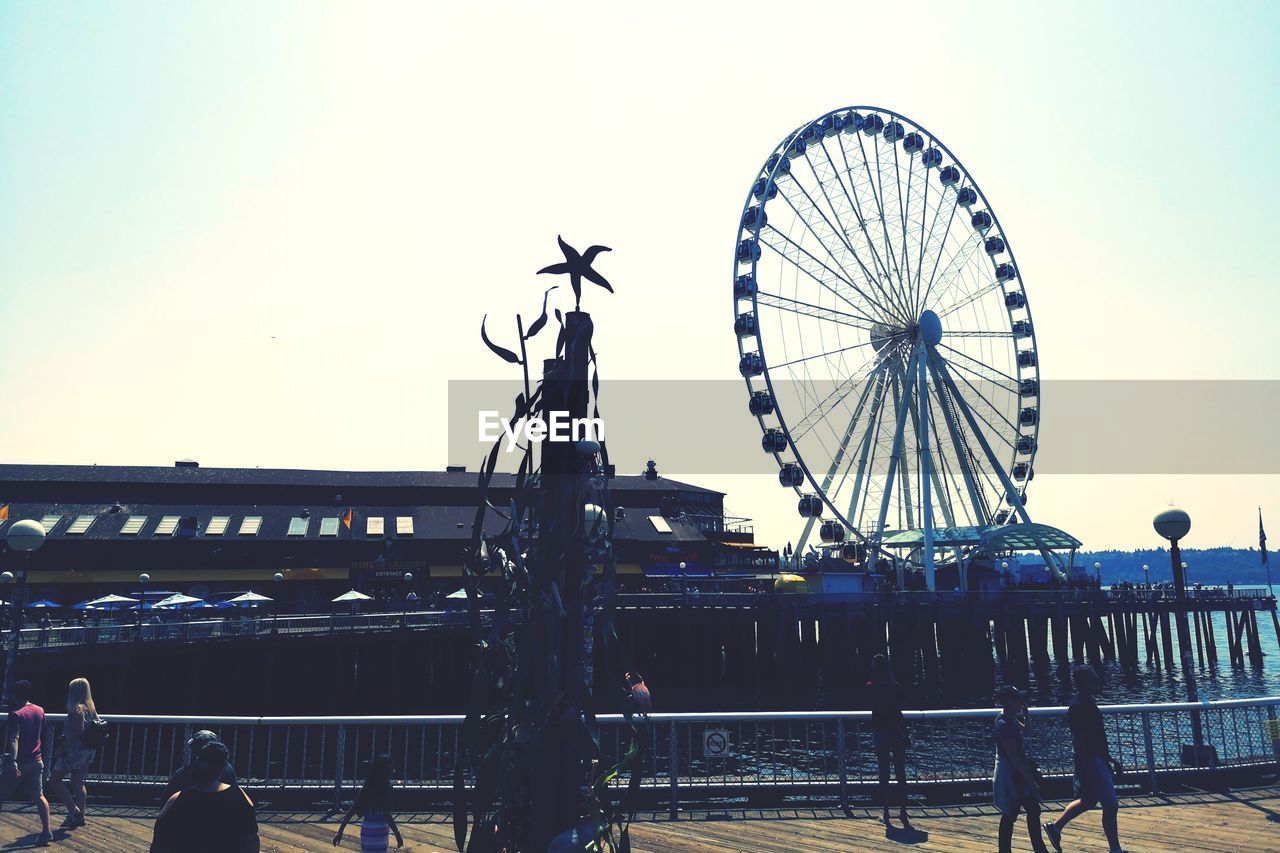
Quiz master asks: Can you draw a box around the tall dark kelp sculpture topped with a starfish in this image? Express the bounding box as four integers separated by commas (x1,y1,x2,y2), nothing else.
453,240,648,853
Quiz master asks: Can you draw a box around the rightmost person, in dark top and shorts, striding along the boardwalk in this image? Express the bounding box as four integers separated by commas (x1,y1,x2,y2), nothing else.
1044,665,1124,853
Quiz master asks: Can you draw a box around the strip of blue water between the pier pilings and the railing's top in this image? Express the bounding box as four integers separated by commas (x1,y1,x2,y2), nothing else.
967,584,1280,707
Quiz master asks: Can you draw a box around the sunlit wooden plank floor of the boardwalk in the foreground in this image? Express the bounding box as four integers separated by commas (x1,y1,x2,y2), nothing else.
0,788,1280,853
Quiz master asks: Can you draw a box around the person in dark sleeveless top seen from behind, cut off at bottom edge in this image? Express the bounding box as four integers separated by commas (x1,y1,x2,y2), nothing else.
151,740,260,853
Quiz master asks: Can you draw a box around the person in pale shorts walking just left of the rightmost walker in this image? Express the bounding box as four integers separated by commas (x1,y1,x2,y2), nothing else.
992,684,1047,853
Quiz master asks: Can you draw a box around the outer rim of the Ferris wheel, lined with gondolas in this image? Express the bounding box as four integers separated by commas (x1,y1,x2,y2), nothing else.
731,104,1043,543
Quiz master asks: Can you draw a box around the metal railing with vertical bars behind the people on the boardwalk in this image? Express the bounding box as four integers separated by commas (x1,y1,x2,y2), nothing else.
30,697,1280,811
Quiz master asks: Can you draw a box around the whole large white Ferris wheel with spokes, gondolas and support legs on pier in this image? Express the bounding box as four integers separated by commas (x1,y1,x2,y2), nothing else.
733,106,1041,578
